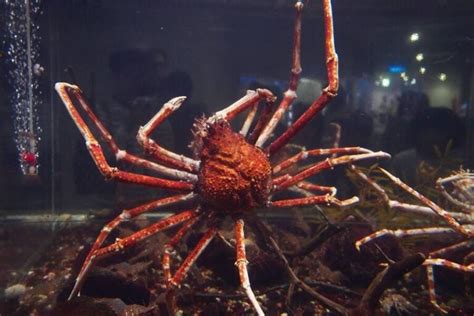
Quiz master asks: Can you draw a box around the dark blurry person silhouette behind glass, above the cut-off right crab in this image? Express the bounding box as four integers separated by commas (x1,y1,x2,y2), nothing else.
391,107,465,185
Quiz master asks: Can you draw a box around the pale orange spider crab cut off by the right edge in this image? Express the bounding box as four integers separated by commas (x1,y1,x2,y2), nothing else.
350,166,474,313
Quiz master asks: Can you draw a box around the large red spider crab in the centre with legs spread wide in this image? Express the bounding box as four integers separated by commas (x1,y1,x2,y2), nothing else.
55,0,389,315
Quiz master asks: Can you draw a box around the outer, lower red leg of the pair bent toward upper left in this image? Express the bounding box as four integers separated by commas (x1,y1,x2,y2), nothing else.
55,83,194,191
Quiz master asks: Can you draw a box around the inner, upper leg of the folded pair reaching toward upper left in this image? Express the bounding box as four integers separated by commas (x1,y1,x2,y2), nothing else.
56,82,197,182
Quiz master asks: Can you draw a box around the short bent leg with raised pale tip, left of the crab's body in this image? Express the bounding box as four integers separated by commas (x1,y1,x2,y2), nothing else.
137,97,199,172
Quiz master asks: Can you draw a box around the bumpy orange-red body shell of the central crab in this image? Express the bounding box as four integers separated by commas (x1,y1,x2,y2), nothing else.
197,120,272,212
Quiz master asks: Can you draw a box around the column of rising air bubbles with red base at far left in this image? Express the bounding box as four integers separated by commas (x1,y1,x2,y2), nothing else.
5,0,43,175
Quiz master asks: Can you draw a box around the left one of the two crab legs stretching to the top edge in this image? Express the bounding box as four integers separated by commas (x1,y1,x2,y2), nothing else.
255,1,304,147
